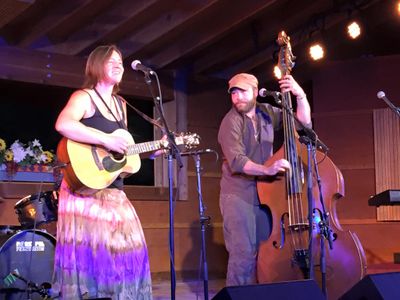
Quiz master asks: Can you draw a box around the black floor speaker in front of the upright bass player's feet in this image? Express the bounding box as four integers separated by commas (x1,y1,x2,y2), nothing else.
212,280,325,300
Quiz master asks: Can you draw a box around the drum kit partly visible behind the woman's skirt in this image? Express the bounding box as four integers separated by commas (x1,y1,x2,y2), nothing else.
0,191,58,300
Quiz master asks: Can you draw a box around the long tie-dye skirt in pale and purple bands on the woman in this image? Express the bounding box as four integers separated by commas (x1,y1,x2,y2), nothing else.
53,183,152,300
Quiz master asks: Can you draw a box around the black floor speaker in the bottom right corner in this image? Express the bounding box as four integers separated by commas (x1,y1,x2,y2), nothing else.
340,272,400,300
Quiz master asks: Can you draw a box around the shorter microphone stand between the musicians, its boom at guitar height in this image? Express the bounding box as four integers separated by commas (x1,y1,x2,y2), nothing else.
181,149,218,300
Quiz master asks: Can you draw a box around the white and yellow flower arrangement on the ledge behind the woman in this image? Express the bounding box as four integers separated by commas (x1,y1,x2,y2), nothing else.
0,138,56,171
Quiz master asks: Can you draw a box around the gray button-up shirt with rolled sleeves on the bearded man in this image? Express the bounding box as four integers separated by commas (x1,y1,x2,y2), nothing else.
218,104,281,205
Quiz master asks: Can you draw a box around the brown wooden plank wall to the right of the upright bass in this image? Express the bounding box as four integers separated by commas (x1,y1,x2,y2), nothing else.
313,56,400,266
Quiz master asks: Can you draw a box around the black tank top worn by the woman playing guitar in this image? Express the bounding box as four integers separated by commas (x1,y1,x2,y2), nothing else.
81,91,124,190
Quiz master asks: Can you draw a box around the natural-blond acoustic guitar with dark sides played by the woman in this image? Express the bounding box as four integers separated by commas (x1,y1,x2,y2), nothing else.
57,129,200,194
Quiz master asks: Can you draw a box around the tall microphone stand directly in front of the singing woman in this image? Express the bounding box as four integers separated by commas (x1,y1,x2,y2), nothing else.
144,70,183,300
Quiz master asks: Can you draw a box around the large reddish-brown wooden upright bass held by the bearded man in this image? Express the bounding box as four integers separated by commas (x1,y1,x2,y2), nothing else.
257,32,366,299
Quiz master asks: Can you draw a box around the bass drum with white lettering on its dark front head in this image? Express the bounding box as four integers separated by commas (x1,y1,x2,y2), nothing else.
0,230,56,300
